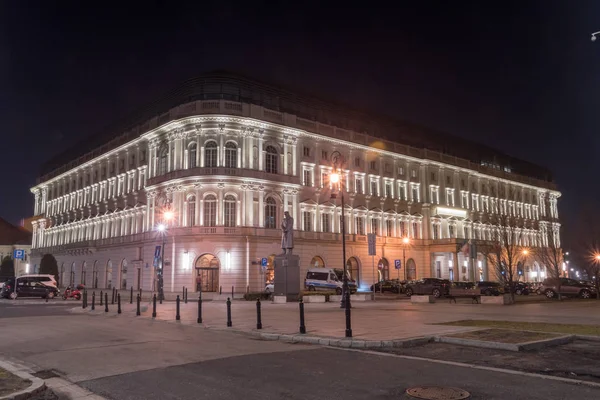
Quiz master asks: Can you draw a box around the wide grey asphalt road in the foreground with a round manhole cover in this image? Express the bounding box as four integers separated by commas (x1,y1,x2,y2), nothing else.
0,301,600,400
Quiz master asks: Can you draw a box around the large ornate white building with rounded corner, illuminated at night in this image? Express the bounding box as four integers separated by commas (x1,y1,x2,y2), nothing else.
31,73,560,292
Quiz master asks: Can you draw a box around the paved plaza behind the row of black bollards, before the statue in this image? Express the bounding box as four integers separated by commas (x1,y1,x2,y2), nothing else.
75,299,600,340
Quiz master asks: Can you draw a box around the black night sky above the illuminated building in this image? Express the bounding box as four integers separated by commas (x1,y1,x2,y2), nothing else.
0,0,600,250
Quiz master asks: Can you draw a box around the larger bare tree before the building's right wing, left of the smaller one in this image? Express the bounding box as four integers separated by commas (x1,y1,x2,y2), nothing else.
482,215,523,302
